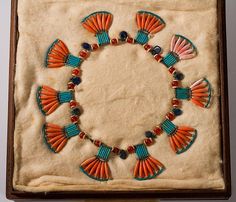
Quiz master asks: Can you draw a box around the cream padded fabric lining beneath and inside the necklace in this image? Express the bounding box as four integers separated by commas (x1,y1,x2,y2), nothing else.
13,0,224,192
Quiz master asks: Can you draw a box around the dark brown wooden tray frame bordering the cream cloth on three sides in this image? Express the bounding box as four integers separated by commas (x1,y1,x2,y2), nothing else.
6,0,231,199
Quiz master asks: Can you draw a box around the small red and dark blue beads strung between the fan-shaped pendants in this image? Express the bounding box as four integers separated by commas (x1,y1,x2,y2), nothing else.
68,34,184,159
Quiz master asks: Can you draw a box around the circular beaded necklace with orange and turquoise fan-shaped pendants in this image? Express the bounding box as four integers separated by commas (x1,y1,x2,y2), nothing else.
37,11,211,181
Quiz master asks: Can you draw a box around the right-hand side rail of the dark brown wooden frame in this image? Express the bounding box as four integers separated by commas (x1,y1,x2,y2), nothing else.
218,0,232,198
